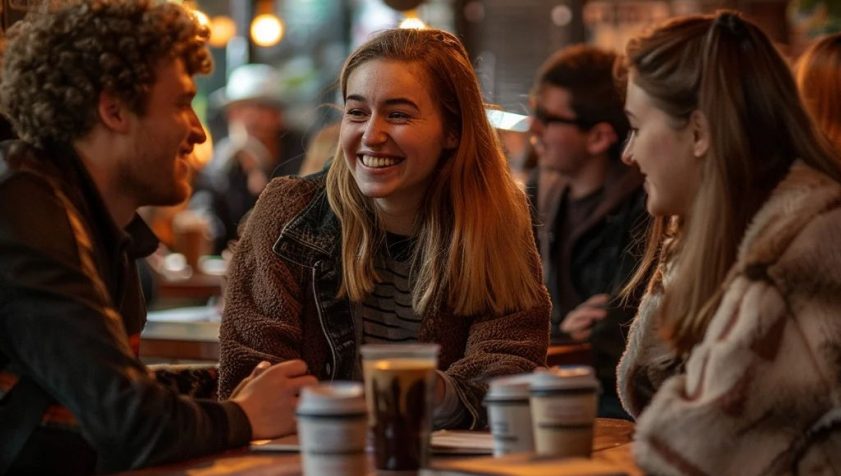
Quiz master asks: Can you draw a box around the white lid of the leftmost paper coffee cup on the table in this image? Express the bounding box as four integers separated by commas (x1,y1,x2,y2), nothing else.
298,381,367,416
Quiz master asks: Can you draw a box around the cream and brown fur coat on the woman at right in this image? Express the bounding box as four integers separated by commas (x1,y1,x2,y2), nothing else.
618,162,841,476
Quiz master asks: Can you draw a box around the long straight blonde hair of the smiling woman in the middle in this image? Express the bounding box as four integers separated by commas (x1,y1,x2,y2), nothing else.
327,29,543,315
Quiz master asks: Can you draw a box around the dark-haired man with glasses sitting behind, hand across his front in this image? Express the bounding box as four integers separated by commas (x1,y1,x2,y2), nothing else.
529,45,648,418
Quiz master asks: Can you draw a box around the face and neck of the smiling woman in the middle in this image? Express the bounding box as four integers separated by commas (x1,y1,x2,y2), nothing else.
340,60,458,231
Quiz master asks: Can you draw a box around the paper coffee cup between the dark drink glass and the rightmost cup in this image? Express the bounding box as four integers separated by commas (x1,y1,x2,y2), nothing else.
485,374,534,456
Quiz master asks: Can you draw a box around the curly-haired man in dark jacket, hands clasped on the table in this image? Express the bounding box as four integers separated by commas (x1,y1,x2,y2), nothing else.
0,0,314,474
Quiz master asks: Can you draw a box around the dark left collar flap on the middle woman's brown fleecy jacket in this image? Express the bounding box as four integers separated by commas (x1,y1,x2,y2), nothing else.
272,178,341,267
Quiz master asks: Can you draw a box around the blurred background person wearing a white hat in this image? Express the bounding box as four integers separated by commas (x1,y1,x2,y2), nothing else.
190,64,305,253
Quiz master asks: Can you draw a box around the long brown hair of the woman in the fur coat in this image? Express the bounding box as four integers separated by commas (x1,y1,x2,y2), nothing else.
626,12,841,352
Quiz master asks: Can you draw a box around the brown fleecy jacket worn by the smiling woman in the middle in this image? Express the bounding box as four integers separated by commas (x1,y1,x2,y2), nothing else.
219,174,550,428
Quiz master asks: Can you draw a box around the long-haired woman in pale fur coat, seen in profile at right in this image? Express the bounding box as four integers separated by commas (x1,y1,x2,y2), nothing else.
618,12,841,475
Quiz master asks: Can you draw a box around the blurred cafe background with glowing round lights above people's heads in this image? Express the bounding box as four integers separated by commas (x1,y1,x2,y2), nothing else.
190,0,841,137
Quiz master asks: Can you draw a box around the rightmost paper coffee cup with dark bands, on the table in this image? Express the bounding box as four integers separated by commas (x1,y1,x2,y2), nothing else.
531,366,599,457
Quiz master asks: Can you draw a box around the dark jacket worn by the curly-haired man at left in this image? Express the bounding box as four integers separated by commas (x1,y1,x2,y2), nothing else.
0,141,250,474
